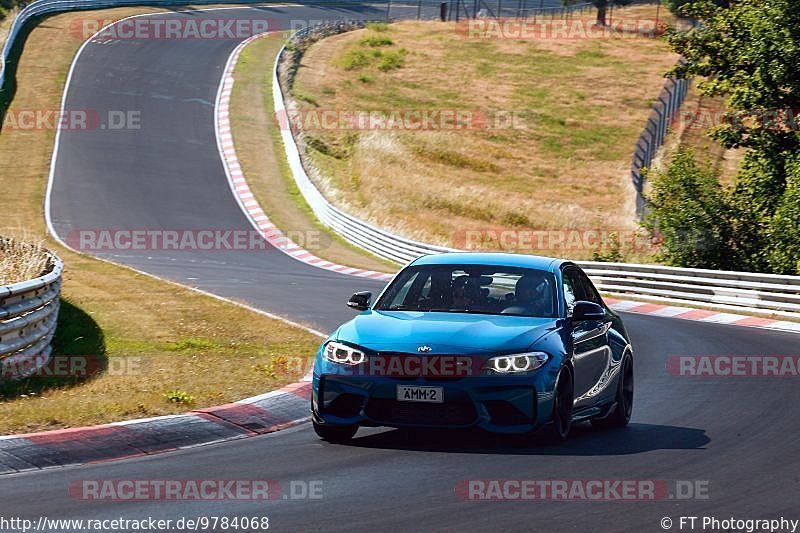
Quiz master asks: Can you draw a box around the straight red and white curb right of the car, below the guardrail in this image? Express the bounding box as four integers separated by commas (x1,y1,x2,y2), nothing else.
604,298,800,333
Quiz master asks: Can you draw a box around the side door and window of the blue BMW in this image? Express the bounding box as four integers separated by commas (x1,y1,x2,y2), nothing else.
562,265,611,406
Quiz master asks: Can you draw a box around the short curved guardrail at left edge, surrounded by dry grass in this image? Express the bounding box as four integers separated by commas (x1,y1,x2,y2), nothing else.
0,253,64,377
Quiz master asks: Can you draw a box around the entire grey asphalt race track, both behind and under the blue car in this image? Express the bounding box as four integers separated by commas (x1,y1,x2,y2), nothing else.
0,7,800,531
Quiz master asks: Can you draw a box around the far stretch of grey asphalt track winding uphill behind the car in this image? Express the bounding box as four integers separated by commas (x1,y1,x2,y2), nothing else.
50,7,384,331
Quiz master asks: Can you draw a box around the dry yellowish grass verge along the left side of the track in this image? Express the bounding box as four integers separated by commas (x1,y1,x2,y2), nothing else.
0,8,319,434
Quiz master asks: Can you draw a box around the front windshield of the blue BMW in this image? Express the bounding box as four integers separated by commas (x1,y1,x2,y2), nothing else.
375,265,558,318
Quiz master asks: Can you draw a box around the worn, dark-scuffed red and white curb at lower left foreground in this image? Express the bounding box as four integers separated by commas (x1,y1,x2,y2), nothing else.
0,370,311,474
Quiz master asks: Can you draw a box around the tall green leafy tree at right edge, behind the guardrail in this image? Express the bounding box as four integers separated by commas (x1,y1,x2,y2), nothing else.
668,0,800,273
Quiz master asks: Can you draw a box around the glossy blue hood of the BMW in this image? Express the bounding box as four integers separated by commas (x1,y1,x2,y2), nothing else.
335,310,557,354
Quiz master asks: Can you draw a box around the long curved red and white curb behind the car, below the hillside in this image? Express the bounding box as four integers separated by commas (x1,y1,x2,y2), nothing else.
214,33,392,281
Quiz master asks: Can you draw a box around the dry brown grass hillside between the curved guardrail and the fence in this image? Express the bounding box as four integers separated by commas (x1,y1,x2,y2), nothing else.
294,6,676,258
